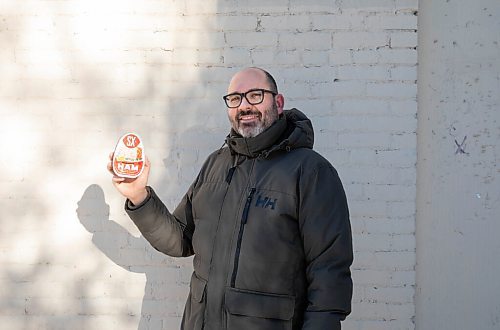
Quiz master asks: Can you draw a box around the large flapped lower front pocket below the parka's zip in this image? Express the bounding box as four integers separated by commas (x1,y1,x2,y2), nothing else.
225,288,295,330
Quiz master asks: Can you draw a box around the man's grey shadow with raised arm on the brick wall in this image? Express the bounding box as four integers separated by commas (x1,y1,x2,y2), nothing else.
76,184,187,330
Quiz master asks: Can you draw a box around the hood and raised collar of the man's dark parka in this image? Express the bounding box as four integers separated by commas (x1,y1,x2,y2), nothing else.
226,108,314,158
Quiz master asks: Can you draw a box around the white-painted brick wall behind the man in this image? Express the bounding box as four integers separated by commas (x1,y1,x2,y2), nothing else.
0,0,417,330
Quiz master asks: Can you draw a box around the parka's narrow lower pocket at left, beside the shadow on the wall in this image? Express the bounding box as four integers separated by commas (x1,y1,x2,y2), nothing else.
182,272,207,330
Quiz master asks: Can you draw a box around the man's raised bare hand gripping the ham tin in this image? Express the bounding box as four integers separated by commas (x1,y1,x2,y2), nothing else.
108,153,151,205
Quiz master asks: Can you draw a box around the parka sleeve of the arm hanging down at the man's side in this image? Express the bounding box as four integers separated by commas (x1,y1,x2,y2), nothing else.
298,164,353,330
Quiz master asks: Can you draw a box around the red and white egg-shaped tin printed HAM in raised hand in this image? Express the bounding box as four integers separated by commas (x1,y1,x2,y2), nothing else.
113,133,145,179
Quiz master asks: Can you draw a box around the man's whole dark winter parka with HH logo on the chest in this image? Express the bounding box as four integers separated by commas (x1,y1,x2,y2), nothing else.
126,109,353,330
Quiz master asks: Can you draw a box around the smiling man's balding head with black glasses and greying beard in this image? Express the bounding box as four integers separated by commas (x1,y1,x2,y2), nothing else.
224,68,284,137
